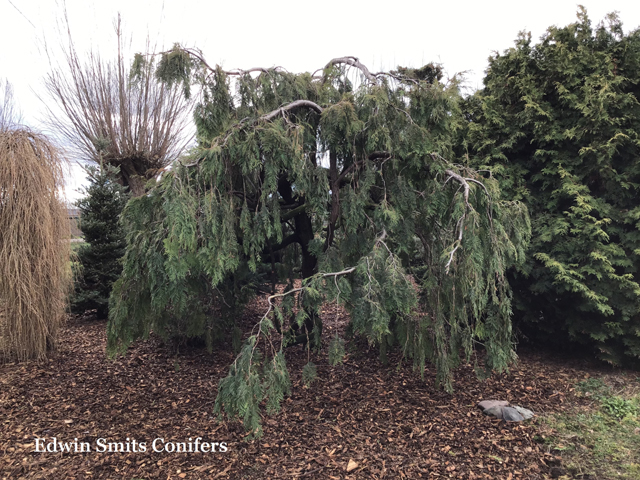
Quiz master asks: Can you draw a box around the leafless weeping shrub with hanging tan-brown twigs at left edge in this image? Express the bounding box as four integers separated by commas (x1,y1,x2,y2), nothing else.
0,130,72,361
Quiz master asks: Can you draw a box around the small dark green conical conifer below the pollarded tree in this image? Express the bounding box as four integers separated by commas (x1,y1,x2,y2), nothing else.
72,165,128,318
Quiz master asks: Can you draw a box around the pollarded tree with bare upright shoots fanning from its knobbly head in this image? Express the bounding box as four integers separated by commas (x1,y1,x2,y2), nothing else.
45,16,192,196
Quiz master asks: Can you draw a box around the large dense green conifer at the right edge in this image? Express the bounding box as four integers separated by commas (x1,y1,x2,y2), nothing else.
466,9,640,363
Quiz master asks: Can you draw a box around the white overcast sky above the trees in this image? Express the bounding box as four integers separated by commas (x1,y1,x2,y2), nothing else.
0,0,640,199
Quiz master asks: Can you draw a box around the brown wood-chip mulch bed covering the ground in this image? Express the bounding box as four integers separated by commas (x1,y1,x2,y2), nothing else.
0,306,620,480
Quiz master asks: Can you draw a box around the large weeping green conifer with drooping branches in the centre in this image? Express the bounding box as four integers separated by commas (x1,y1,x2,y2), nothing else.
108,51,529,433
